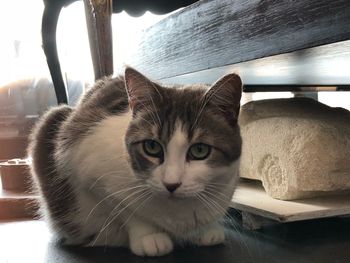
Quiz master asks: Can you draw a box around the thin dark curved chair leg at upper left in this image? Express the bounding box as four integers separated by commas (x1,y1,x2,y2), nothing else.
41,1,68,104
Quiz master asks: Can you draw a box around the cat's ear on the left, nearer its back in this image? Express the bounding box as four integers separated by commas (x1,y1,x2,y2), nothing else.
125,67,159,112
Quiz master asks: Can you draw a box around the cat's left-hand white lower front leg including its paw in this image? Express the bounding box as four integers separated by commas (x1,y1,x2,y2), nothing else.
128,219,174,257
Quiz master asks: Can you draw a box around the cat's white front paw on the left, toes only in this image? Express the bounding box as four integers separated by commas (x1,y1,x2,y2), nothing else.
130,233,173,257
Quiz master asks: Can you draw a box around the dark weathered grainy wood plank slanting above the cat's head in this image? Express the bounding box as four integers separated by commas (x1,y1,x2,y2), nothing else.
127,0,350,79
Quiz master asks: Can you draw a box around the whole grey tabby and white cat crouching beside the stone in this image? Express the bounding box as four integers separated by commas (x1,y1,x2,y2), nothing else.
28,67,242,256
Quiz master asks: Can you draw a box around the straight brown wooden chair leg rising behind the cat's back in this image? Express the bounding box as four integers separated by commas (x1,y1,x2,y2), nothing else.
84,0,113,80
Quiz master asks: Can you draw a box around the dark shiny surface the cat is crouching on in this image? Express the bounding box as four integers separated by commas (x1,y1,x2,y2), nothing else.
0,211,350,263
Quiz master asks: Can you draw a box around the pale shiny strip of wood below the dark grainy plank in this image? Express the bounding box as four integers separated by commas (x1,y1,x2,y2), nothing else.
160,41,350,91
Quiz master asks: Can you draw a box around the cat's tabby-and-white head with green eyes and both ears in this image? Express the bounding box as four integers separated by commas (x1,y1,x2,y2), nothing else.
125,69,241,198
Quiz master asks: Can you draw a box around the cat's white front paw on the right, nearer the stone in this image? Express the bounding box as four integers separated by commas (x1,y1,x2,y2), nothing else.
192,223,225,246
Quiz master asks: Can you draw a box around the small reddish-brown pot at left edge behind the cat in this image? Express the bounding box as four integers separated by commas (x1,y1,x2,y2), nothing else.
0,159,31,192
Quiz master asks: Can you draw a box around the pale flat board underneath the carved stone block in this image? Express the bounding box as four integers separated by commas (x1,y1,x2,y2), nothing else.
231,180,350,228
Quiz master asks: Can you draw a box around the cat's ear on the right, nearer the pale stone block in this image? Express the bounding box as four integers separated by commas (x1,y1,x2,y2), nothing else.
205,74,242,124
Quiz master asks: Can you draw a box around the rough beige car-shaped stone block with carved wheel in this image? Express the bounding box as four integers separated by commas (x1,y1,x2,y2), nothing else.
239,98,350,200
